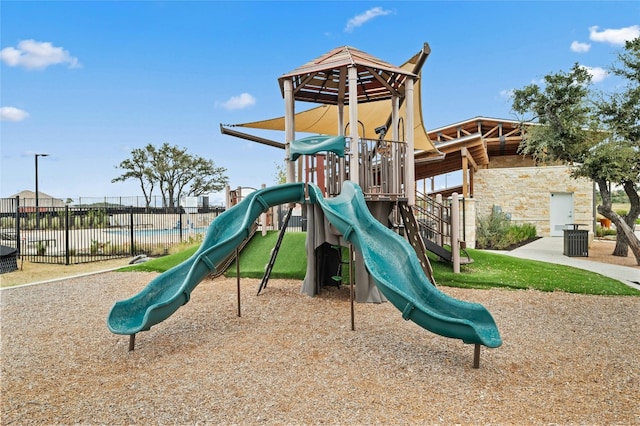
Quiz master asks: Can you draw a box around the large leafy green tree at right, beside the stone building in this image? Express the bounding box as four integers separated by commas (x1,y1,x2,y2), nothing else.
513,38,640,265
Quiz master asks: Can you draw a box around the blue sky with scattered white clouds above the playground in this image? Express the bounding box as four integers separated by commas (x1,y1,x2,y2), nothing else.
0,0,640,201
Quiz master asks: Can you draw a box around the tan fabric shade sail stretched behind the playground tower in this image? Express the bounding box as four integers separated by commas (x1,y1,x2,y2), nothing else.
222,43,438,154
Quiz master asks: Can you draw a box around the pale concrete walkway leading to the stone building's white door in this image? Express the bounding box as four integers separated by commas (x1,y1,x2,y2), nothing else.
503,237,640,290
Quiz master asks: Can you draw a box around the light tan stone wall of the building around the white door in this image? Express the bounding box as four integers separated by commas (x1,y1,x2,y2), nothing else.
473,164,593,236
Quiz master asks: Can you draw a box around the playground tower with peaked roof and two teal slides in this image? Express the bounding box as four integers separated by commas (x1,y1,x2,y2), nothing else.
107,44,502,368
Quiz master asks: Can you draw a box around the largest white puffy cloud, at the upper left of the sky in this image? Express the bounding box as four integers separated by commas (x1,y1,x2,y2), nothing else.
0,40,80,70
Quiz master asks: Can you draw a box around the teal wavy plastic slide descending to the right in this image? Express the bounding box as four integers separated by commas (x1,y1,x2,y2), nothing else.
309,181,502,348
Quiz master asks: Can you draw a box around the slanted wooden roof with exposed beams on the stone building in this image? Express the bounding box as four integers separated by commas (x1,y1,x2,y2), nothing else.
415,117,522,179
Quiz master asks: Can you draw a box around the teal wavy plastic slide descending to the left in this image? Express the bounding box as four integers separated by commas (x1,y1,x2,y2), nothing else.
107,183,304,335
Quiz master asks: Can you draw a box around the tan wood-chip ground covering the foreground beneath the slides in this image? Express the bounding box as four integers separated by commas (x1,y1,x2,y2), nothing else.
0,272,640,425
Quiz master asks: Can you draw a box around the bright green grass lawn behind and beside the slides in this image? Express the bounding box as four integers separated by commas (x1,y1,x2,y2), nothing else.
121,231,640,296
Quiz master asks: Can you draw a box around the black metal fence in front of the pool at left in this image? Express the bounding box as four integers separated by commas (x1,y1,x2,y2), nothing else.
0,197,224,265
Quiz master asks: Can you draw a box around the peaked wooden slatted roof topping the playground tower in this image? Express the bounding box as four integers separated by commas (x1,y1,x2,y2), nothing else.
278,46,416,105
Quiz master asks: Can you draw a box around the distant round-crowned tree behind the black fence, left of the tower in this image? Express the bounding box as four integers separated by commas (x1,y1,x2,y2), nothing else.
112,142,229,208
